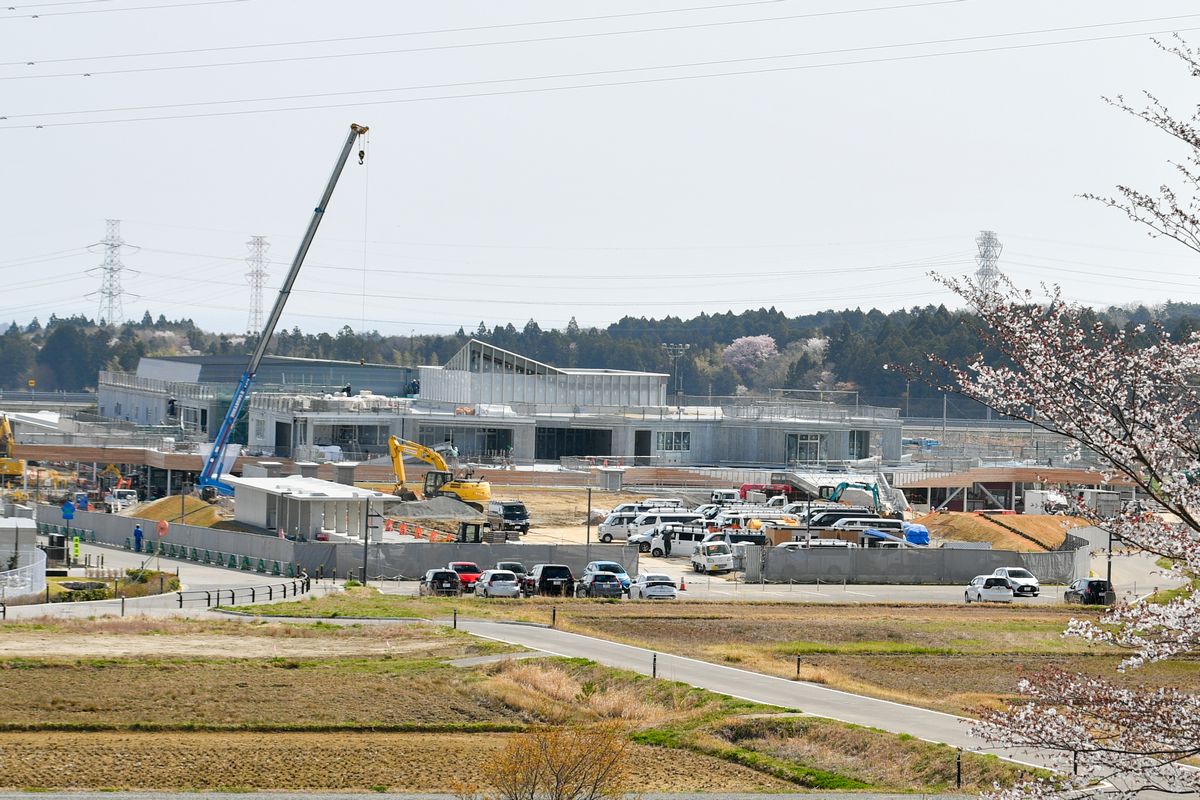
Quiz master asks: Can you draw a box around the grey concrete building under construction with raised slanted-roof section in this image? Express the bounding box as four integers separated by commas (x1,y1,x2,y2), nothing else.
250,341,901,467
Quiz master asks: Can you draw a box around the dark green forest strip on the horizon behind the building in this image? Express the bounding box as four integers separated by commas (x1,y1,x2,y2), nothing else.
0,303,1200,416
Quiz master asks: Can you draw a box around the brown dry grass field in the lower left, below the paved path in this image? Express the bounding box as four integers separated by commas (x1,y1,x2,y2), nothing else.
0,619,1036,793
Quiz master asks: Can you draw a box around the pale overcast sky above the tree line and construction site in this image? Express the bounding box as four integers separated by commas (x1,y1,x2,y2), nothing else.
0,0,1200,335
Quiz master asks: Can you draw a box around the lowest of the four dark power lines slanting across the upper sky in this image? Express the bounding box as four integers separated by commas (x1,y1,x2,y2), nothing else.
0,23,1200,131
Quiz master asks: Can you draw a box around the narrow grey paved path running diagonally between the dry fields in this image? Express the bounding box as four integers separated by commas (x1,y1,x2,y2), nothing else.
458,619,1043,764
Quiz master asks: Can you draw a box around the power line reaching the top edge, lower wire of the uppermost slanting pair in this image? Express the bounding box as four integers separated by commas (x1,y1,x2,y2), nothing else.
0,0,974,80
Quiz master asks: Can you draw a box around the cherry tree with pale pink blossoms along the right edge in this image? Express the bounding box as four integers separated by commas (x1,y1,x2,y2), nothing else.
924,38,1200,800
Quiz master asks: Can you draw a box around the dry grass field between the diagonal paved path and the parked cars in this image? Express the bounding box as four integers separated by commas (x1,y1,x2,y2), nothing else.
246,589,1200,714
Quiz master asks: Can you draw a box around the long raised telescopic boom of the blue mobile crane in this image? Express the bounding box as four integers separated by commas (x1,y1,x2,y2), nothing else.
197,125,367,500
